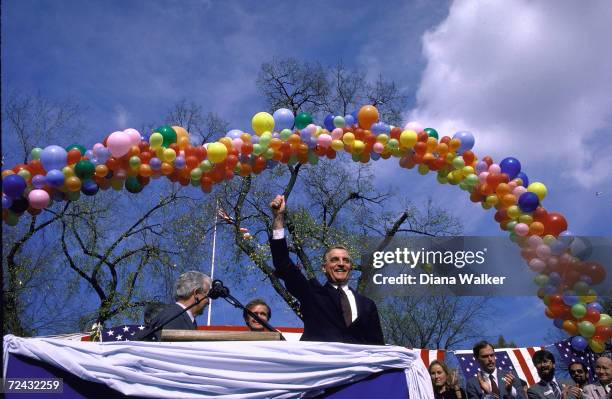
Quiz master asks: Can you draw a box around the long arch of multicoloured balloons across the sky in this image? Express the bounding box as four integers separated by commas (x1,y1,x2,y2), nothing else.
2,105,612,352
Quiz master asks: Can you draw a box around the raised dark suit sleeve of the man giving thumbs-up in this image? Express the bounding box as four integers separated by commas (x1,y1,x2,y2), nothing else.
270,238,309,302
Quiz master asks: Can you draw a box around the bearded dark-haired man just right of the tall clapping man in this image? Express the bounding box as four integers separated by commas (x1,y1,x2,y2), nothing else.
527,349,580,399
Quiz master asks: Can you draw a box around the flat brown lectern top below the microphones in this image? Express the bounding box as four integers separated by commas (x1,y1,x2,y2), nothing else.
161,330,282,342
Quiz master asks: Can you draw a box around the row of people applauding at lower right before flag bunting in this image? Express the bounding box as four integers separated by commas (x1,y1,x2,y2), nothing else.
429,341,612,399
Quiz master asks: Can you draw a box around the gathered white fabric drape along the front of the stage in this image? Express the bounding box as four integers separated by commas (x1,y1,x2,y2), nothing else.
4,335,433,399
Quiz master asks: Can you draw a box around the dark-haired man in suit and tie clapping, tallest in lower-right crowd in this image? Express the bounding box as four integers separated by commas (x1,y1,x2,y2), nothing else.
466,341,525,399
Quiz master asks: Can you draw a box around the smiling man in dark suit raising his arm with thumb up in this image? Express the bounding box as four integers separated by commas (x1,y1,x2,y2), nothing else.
270,195,384,345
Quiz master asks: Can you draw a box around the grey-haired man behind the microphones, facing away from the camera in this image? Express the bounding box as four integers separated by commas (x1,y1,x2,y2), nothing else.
140,271,211,341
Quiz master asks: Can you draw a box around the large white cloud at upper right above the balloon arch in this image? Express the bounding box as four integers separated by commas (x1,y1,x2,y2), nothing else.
407,0,612,188
